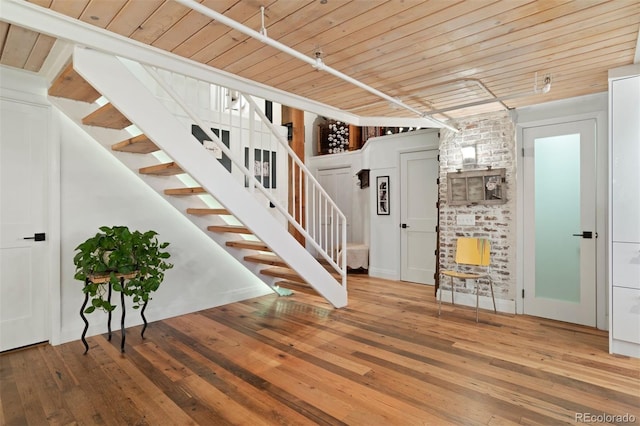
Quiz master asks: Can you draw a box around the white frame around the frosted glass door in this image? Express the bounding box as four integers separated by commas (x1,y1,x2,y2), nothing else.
515,111,609,330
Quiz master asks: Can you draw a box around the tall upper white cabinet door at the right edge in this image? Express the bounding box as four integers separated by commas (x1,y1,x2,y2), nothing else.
611,76,640,243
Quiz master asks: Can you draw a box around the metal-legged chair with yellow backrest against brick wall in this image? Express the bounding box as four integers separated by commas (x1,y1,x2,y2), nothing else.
438,237,497,322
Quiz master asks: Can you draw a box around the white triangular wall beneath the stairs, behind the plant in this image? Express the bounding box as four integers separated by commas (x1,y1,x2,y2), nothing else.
0,65,271,344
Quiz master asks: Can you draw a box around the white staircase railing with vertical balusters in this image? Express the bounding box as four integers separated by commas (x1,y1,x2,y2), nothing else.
138,60,347,289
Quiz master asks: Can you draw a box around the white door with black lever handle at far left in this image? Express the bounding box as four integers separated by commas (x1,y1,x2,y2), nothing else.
0,100,49,351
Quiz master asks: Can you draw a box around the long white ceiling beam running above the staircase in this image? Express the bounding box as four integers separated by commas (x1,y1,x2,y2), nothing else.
0,0,440,127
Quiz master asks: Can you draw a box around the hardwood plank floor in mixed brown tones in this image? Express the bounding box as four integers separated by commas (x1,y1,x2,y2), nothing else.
0,275,640,425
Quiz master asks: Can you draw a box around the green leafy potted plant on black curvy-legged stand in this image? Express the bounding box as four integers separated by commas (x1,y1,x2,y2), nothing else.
73,226,173,314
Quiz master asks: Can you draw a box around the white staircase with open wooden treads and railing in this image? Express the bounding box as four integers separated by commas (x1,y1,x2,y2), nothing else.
50,48,347,308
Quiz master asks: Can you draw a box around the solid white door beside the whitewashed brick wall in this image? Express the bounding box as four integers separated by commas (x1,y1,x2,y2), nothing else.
400,150,439,284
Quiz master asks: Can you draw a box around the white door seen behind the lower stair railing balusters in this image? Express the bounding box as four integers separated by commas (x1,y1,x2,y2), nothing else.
318,167,353,243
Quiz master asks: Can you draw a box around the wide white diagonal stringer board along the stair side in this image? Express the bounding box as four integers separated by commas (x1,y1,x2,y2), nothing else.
74,47,347,308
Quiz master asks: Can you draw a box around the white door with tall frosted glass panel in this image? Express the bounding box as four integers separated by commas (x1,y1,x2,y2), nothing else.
523,120,597,326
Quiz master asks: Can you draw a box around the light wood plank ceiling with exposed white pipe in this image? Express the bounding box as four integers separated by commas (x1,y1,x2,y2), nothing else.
0,0,640,118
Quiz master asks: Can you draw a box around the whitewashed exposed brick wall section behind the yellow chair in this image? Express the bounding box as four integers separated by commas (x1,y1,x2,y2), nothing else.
440,112,516,300
